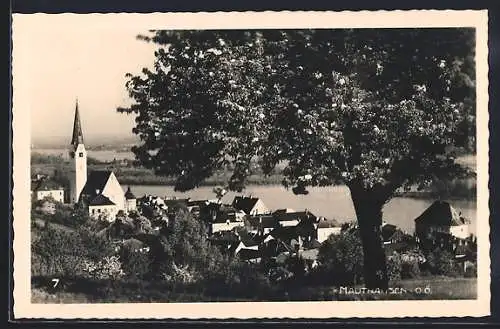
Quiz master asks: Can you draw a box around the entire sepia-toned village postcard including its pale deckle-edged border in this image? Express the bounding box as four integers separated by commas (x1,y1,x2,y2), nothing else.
12,11,490,318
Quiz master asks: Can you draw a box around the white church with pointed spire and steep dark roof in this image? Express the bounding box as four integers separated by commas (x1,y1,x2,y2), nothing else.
70,100,137,221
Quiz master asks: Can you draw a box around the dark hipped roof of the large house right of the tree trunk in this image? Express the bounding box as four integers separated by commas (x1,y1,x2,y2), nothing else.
415,201,468,226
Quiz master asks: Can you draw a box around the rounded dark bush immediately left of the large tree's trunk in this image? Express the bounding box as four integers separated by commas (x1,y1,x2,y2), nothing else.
318,231,363,285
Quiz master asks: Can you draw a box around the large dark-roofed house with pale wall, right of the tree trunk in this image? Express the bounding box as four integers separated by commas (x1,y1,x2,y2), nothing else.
415,201,470,240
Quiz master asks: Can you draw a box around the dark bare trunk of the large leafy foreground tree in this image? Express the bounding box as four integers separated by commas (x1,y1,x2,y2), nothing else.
350,186,389,290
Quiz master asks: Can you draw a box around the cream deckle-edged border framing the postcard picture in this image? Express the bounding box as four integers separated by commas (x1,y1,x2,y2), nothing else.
12,10,490,319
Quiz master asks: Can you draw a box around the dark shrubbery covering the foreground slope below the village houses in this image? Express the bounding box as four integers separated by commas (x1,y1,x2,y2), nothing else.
32,197,476,301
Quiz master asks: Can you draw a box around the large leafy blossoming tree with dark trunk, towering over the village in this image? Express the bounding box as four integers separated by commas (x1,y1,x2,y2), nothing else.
118,29,475,288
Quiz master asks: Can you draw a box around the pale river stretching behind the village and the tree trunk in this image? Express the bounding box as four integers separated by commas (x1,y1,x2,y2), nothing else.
123,185,476,234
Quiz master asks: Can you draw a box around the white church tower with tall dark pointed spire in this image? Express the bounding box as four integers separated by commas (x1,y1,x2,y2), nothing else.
70,99,87,204
